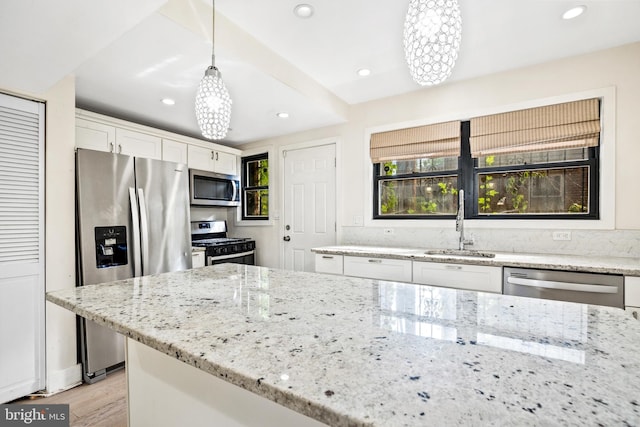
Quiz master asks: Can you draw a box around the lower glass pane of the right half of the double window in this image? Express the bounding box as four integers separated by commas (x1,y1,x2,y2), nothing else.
477,166,589,215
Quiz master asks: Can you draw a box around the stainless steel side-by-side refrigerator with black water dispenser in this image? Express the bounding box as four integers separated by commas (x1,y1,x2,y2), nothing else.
76,148,191,383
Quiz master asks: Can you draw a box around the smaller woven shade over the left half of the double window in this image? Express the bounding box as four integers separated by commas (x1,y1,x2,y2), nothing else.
371,122,460,163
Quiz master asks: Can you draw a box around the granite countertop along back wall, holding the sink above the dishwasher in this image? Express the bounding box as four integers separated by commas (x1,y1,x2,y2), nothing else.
312,245,640,276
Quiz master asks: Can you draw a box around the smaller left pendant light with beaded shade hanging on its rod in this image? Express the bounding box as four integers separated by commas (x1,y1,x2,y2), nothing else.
196,0,231,139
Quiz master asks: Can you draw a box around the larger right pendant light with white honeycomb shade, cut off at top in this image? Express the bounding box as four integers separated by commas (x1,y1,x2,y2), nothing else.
404,0,462,86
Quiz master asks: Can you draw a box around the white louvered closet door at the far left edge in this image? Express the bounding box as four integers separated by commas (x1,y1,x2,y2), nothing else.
0,94,45,403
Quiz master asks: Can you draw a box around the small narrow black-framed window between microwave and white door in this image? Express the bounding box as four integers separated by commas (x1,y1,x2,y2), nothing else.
242,153,269,220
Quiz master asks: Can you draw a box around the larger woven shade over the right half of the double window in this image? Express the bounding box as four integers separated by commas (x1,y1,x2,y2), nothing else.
469,99,600,157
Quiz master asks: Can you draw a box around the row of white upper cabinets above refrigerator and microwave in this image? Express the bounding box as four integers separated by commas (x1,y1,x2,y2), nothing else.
76,109,241,175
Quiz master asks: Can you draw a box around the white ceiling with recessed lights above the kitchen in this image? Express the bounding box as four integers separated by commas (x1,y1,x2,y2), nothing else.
0,0,640,145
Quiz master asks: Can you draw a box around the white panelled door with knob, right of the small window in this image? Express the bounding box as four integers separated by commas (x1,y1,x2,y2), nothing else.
282,144,336,271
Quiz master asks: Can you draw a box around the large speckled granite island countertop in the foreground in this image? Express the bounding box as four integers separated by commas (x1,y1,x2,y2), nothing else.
47,264,640,426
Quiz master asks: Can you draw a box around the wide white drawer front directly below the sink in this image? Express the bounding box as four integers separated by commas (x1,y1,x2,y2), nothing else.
413,261,502,294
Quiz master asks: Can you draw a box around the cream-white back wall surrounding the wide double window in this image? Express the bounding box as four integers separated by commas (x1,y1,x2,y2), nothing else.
234,43,640,267
